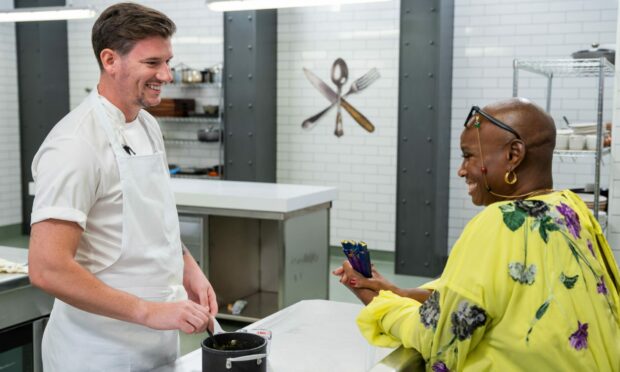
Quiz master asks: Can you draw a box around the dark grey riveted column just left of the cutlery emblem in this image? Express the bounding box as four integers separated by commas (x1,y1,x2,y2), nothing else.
224,10,277,182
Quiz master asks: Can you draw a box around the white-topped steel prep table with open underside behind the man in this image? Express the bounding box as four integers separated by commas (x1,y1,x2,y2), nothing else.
172,179,336,322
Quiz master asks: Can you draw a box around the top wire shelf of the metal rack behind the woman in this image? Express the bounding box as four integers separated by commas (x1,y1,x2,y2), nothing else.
514,58,614,77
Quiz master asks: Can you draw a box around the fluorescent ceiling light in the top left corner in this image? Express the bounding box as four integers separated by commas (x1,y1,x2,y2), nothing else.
0,6,96,22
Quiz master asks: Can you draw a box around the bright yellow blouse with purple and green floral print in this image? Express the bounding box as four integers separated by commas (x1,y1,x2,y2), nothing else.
357,191,620,372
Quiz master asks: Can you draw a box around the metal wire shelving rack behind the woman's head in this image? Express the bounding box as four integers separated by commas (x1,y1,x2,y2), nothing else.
512,57,614,219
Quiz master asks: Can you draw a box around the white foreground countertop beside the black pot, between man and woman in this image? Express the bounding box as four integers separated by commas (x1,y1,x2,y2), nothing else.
155,300,424,372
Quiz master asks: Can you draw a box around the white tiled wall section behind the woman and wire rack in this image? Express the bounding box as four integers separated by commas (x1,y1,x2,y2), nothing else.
449,0,618,250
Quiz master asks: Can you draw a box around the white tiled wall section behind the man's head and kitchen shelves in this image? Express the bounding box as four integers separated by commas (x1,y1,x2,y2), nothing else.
68,0,224,167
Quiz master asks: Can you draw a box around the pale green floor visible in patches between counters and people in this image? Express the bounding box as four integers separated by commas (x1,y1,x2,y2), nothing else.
0,226,430,355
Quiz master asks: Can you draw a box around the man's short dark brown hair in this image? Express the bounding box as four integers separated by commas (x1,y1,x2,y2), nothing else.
91,3,176,69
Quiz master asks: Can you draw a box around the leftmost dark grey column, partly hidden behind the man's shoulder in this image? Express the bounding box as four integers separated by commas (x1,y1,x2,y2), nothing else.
15,0,70,233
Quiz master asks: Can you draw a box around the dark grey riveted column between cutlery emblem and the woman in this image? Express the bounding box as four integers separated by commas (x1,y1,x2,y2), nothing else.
395,0,454,276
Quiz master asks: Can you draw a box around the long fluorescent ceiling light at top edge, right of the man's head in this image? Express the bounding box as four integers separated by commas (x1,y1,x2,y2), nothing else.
207,0,391,12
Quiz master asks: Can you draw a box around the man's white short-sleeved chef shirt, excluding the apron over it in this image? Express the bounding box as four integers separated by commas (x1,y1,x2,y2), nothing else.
30,96,168,273
